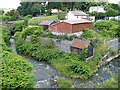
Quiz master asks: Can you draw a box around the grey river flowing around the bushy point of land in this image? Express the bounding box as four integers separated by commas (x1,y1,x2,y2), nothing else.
10,38,120,88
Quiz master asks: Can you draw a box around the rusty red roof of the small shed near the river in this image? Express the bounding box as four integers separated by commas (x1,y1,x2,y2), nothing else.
70,39,90,49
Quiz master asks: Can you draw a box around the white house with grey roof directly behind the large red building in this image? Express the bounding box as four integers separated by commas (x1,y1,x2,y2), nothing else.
65,11,88,20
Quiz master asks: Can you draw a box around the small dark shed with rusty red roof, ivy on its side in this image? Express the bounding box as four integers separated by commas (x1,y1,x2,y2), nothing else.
70,39,94,57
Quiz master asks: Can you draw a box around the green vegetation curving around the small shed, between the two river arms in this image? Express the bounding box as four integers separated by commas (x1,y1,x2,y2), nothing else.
14,24,107,79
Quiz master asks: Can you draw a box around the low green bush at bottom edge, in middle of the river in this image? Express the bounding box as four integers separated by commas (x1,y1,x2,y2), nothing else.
57,78,72,88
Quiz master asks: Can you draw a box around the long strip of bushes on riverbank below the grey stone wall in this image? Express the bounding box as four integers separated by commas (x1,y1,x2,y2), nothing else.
14,32,93,79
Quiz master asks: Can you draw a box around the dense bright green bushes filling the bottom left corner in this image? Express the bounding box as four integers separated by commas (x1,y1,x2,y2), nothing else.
1,51,34,89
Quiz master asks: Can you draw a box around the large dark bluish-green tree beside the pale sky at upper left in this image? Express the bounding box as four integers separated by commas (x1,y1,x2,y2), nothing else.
17,2,45,16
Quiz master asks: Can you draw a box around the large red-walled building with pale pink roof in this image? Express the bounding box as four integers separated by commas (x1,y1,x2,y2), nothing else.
49,19,92,34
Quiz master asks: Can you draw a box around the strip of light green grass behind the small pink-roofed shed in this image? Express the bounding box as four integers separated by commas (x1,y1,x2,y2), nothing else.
28,16,58,25
